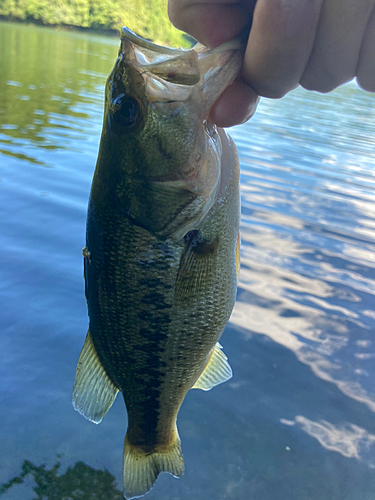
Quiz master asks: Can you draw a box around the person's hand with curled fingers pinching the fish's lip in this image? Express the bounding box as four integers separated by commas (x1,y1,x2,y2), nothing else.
169,0,375,127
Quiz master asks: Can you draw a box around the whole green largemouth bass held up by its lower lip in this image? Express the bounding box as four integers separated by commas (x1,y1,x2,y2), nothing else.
72,28,243,499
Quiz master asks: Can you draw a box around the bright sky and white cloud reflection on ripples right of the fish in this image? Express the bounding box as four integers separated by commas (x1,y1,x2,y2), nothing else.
232,84,375,422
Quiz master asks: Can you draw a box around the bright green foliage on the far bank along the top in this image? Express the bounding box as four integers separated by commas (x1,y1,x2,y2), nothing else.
0,0,190,47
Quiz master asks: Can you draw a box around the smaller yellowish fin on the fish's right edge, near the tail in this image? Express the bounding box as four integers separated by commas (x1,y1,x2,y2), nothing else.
192,342,232,391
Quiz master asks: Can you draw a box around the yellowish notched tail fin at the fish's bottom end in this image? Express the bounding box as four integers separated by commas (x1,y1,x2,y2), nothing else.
122,429,184,499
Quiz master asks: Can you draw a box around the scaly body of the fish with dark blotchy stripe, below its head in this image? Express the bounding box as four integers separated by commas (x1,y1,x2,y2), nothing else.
85,164,238,448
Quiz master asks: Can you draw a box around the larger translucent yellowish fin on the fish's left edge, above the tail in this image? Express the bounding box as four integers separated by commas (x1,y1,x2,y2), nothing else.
72,330,118,424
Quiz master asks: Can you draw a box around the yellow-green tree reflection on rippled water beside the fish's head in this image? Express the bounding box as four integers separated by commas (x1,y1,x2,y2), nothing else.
0,20,118,166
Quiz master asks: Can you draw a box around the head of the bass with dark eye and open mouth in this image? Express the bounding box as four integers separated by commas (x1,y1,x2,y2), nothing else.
97,28,243,238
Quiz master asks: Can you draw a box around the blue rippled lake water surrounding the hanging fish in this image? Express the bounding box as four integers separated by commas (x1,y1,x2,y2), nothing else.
0,23,375,500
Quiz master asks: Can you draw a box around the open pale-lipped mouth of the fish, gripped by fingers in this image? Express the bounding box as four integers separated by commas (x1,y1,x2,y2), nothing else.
120,28,245,114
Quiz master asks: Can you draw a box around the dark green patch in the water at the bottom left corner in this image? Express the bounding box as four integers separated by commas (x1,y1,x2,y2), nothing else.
0,460,123,500
